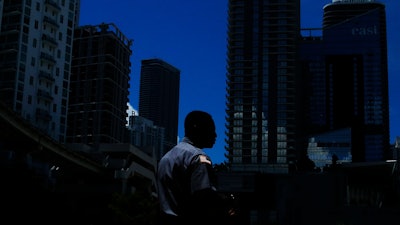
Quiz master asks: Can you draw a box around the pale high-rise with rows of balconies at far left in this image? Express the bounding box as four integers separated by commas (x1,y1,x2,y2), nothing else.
0,0,80,142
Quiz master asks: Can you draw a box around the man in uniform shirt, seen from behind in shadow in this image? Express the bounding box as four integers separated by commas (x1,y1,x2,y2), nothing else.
157,111,234,225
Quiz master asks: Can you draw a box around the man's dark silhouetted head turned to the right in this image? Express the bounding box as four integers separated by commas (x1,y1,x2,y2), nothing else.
185,110,217,148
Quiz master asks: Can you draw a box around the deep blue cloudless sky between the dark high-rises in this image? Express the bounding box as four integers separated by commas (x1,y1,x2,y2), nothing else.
80,0,400,163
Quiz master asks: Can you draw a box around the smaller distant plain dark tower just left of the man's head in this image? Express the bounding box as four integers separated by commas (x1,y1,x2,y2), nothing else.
138,59,180,159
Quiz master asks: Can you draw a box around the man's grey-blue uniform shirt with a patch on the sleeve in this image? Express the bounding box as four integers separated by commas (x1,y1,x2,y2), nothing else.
157,137,216,217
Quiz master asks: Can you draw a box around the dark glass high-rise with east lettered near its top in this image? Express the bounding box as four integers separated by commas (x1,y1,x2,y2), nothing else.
322,0,390,162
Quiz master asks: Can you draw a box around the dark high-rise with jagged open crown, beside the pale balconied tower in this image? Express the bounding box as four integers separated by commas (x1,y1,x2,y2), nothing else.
67,24,132,147
